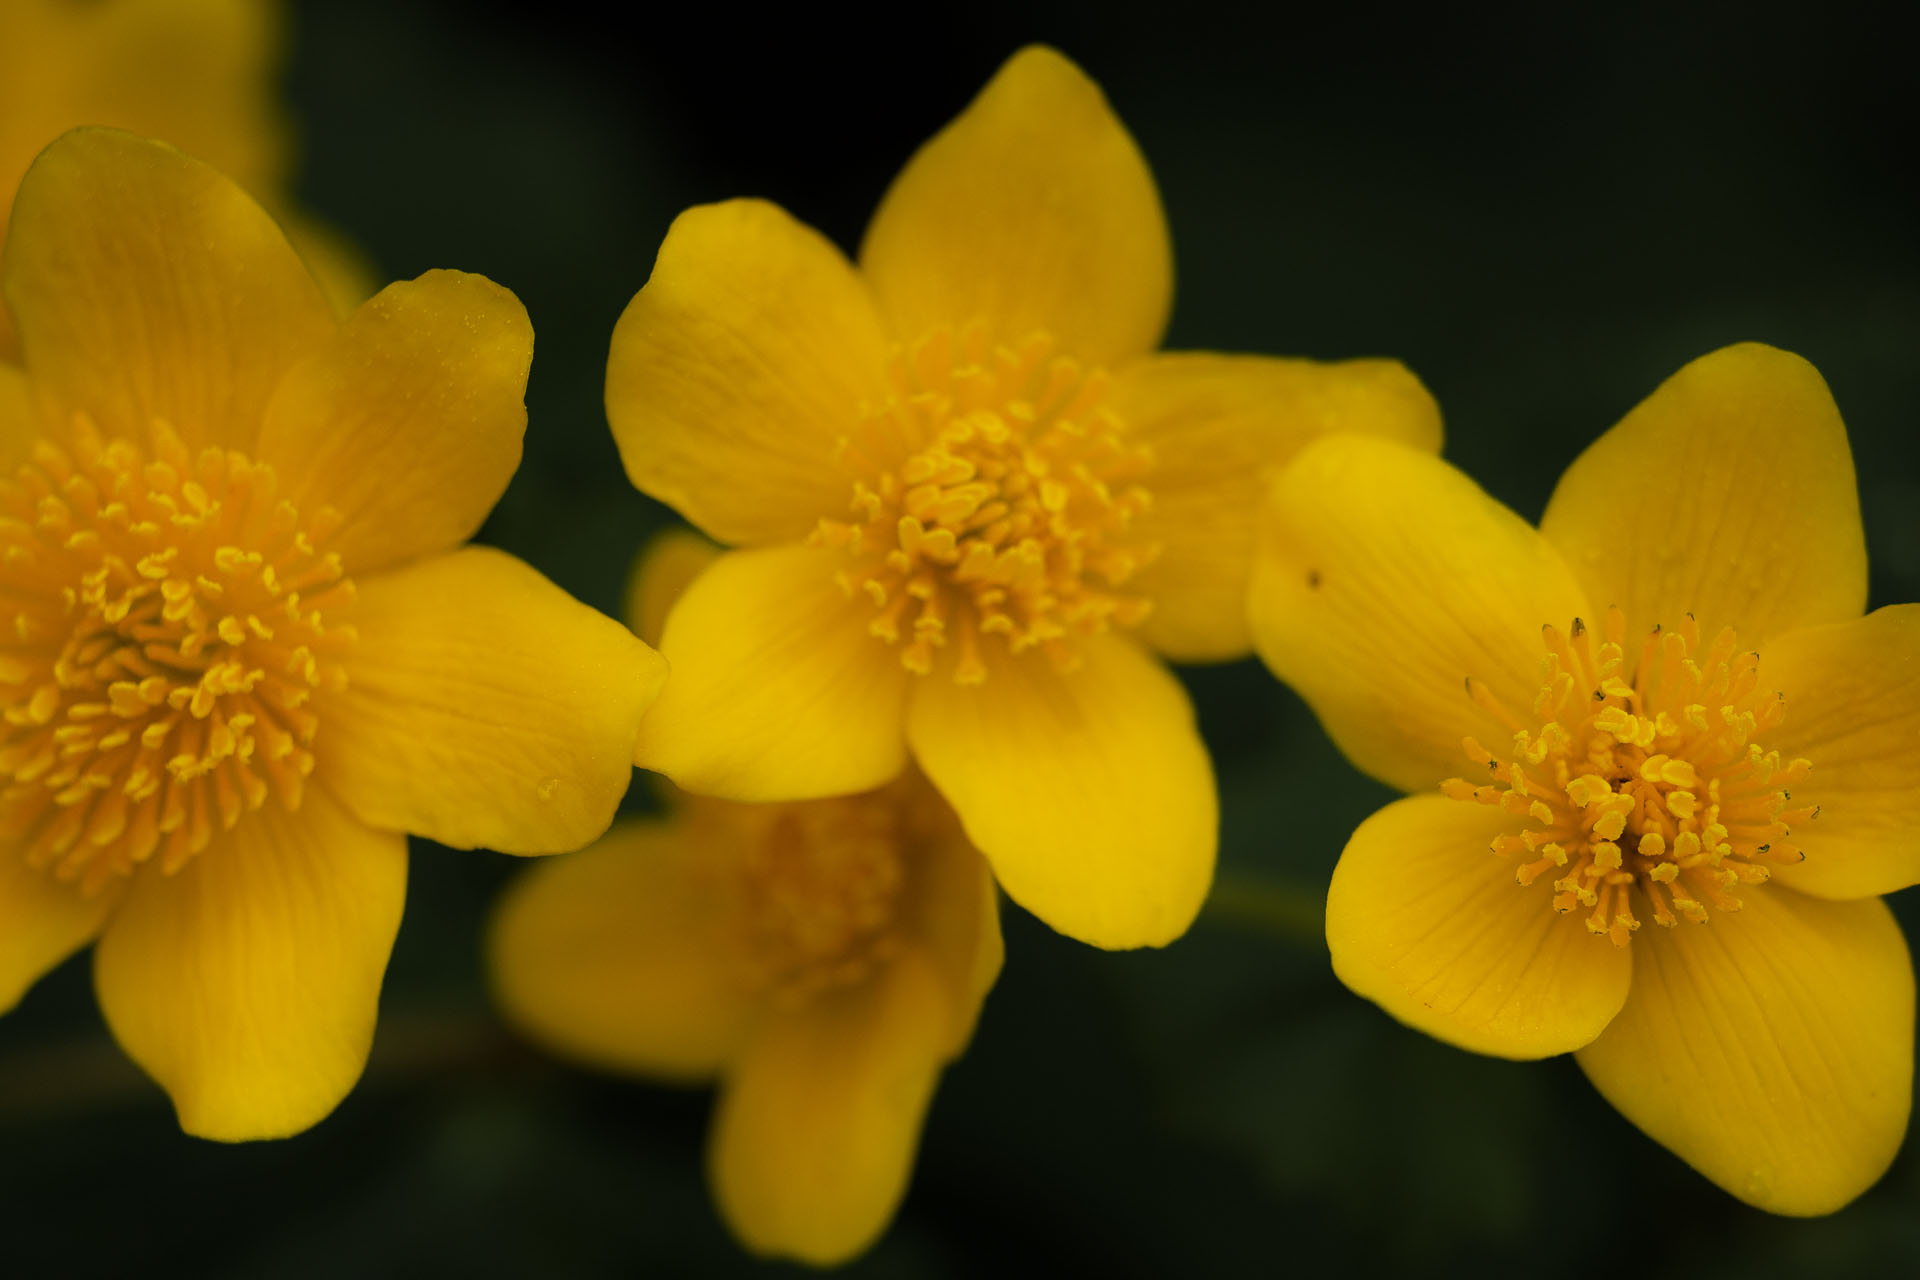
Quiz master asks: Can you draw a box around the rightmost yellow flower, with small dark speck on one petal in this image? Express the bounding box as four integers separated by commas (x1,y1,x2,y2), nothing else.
1252,345,1920,1215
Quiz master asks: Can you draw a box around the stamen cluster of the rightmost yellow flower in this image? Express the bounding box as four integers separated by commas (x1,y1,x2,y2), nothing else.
1442,608,1820,946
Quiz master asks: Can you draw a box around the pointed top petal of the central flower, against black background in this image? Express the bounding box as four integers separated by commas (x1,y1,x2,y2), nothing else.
860,44,1173,365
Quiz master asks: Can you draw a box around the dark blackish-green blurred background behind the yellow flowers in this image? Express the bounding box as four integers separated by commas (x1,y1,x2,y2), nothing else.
0,0,1920,1276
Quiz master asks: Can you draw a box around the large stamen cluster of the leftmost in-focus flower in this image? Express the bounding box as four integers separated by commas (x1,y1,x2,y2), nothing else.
0,416,353,892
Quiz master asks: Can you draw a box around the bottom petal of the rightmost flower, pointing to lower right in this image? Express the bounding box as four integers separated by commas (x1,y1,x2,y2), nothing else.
1580,889,1914,1217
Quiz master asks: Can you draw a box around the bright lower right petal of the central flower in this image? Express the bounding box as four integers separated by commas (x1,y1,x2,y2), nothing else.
906,637,1219,948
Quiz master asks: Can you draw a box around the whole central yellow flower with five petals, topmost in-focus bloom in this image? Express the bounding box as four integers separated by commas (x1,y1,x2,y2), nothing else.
607,48,1440,946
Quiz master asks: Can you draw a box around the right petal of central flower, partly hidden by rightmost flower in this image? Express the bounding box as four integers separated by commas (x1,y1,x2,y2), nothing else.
1112,351,1440,662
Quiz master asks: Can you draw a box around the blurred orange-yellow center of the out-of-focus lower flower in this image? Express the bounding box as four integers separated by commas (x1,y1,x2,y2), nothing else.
743,787,908,1006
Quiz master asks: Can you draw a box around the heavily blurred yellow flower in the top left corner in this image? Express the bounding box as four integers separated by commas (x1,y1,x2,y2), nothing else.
0,0,372,359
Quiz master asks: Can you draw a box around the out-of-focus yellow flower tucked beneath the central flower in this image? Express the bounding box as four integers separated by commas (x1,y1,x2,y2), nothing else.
490,535,1000,1267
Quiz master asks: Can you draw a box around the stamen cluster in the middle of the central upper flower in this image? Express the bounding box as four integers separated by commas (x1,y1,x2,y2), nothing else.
814,324,1158,683
